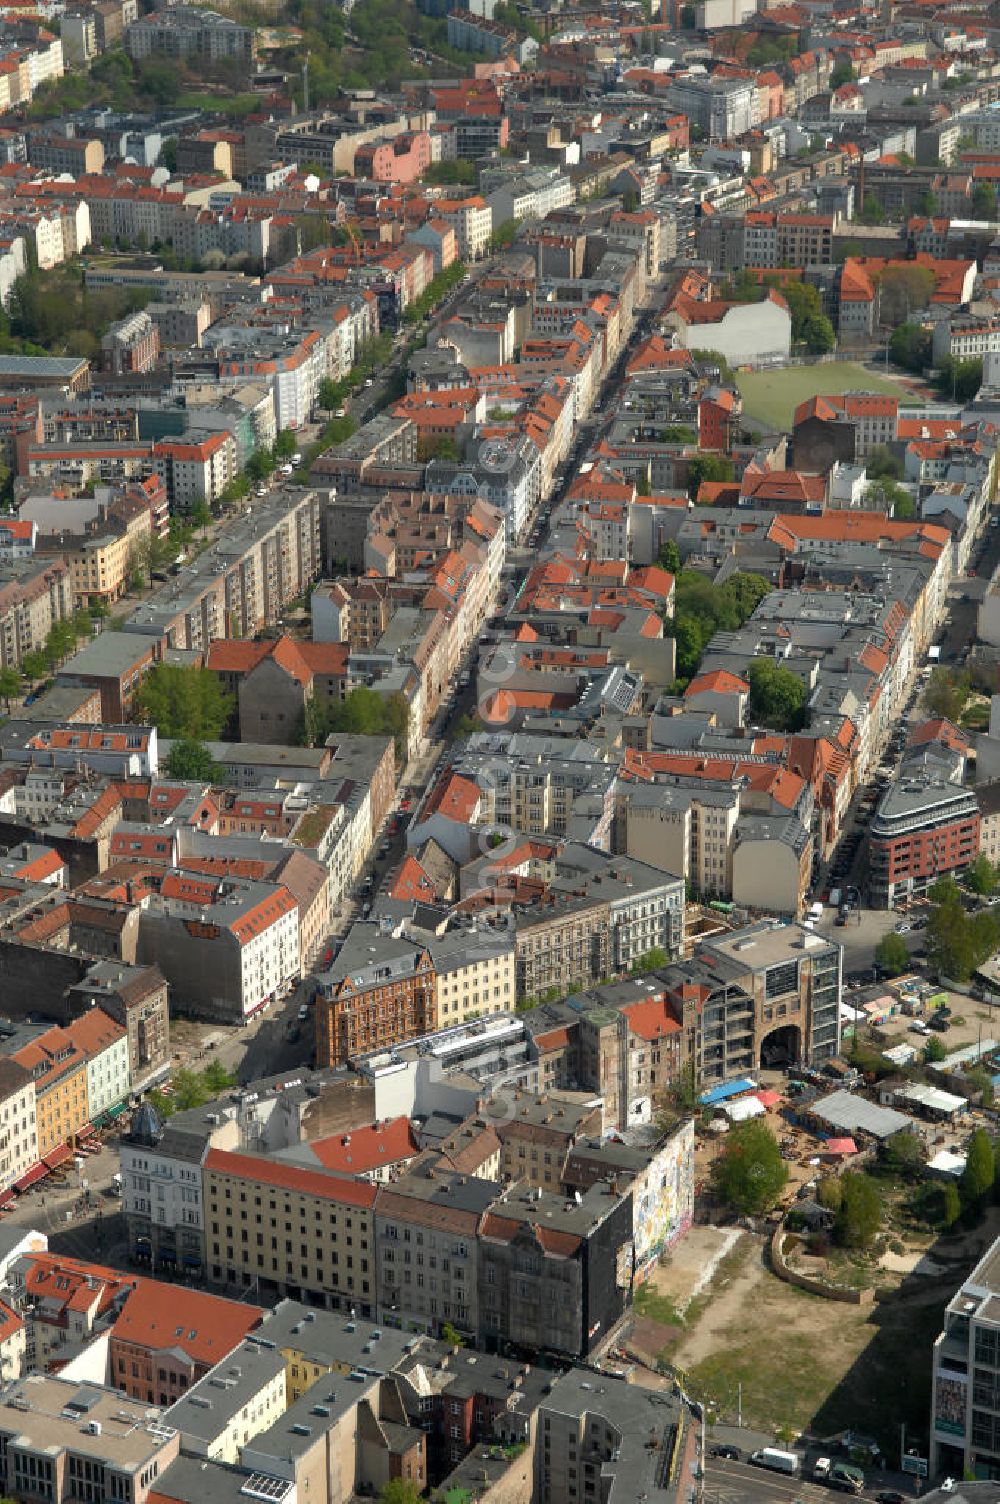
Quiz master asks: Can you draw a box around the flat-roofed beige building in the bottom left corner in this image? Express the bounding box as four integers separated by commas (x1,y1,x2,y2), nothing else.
0,1373,180,1504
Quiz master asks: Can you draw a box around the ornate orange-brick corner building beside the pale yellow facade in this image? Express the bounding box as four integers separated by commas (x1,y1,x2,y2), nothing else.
316,925,438,1068
